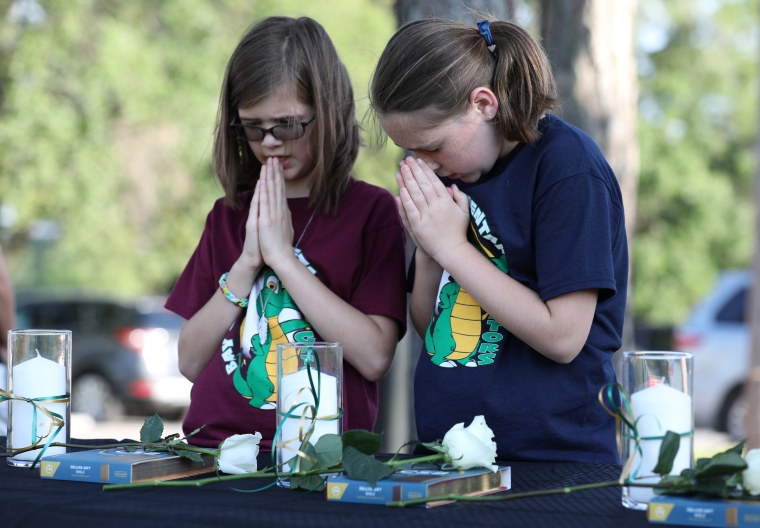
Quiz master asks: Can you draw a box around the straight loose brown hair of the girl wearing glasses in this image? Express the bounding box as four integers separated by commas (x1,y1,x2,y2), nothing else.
214,17,361,212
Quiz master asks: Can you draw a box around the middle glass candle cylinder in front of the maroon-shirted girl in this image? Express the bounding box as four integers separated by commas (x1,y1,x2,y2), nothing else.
273,342,343,487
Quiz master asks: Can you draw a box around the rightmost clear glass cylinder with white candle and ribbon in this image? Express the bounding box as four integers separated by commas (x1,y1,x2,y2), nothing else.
622,351,694,510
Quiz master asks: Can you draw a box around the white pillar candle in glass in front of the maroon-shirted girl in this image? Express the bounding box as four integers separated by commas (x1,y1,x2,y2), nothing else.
277,369,340,471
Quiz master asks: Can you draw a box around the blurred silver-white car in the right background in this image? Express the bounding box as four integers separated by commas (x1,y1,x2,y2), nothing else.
673,270,752,440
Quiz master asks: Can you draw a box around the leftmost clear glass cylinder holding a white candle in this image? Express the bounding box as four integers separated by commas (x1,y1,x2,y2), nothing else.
7,330,71,467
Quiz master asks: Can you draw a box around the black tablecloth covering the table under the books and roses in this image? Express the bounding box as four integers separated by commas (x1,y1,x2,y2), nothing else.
0,437,648,528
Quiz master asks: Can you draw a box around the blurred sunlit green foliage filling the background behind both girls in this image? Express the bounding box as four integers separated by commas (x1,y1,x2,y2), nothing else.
0,0,760,330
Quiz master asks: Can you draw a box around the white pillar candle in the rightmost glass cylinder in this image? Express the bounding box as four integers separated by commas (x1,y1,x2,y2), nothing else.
623,383,692,502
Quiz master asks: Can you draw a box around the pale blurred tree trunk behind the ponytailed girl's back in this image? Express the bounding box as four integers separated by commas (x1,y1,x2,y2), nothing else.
539,0,639,354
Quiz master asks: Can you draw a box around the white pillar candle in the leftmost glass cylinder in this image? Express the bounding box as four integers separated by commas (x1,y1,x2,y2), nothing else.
11,355,68,461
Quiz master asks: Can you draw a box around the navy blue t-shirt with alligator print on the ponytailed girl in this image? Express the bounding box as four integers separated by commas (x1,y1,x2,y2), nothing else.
414,115,628,463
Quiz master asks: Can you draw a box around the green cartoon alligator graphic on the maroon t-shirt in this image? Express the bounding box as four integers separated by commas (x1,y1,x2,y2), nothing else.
233,270,315,409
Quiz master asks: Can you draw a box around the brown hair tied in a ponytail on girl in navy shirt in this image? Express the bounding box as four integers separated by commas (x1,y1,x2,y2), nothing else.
370,18,557,143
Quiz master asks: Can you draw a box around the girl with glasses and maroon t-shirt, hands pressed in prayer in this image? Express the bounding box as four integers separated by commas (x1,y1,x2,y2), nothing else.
166,17,406,449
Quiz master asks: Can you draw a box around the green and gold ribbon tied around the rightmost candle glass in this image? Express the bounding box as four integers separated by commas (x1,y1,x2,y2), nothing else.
598,383,694,485
